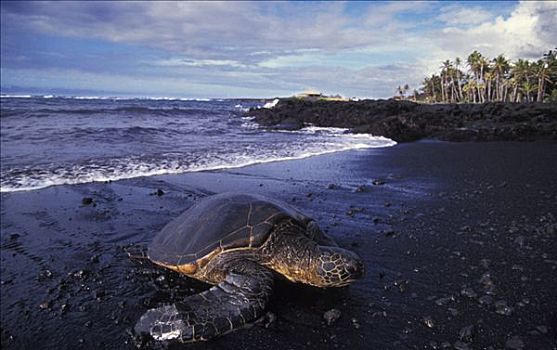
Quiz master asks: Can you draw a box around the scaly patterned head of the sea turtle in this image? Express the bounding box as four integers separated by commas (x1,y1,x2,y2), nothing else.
310,246,364,288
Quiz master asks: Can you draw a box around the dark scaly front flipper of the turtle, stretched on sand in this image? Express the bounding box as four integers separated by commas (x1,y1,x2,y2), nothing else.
134,260,273,342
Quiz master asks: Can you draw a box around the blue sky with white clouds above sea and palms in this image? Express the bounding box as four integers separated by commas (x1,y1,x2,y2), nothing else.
0,1,557,98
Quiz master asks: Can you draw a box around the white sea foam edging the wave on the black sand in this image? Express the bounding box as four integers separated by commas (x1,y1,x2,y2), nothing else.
0,127,396,192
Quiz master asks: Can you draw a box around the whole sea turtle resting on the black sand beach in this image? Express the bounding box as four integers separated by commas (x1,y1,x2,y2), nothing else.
134,193,364,342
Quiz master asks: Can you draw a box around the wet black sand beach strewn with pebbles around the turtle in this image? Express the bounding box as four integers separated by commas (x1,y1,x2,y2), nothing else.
0,142,557,350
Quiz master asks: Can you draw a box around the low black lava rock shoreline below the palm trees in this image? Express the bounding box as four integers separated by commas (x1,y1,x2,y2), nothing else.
247,98,557,142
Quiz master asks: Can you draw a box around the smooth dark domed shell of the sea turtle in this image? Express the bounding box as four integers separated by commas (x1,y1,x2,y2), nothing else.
148,193,310,266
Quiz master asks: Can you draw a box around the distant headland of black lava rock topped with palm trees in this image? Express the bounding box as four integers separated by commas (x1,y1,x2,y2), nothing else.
248,49,557,142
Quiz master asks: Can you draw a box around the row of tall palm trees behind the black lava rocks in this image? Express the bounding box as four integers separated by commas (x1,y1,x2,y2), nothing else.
396,48,557,103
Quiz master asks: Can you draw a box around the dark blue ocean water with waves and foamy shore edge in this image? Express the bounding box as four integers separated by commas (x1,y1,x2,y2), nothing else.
0,96,394,192
